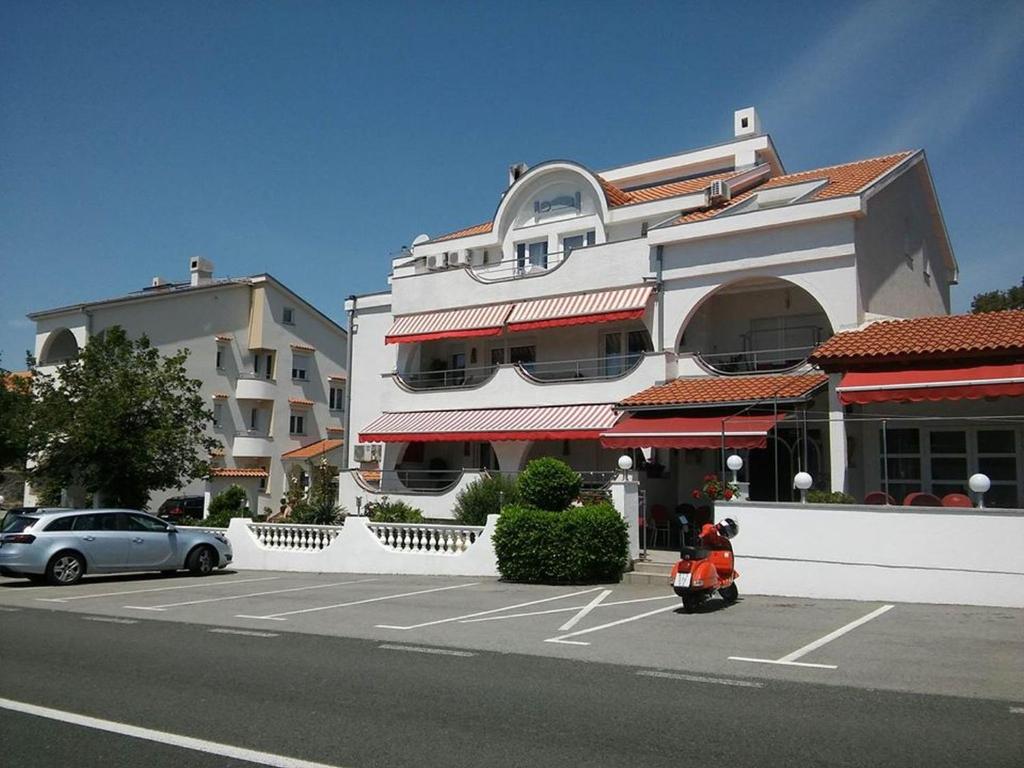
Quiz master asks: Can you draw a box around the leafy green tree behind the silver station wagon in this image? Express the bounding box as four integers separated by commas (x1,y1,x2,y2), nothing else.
29,326,219,509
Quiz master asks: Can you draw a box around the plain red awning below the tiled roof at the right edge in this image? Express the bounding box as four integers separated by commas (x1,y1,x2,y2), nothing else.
837,362,1024,406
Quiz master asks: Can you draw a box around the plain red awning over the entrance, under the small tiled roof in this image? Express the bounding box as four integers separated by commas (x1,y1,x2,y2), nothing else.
601,414,785,449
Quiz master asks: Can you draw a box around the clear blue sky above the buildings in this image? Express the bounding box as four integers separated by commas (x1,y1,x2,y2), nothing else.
0,0,1024,368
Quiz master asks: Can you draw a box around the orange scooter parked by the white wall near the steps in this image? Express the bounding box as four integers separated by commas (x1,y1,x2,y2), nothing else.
672,515,739,613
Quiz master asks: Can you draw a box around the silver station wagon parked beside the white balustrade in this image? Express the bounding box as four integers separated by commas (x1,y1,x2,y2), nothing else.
0,509,231,585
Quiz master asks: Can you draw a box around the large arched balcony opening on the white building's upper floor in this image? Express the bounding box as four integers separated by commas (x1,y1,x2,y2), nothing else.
678,278,833,374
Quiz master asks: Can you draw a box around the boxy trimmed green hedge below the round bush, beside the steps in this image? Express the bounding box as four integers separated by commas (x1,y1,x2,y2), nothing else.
494,502,629,584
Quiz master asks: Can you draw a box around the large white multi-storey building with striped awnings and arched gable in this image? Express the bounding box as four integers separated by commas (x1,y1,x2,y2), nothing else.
341,109,983,517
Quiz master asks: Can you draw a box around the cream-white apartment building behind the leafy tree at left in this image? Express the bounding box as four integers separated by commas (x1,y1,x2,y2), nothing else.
26,258,347,518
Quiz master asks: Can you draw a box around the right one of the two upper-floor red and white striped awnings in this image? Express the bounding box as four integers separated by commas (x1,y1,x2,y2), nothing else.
508,286,654,331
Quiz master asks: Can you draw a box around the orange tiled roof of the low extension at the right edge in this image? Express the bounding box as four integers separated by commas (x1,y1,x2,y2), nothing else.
811,309,1024,368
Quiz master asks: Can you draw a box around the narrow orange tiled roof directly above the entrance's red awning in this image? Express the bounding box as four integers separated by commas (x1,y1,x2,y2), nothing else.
618,374,828,409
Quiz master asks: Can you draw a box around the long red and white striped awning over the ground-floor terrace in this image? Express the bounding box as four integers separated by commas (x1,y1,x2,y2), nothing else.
359,402,618,442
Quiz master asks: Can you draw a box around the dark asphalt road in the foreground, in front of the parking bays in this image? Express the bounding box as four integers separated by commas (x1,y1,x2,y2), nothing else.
0,608,1024,768
